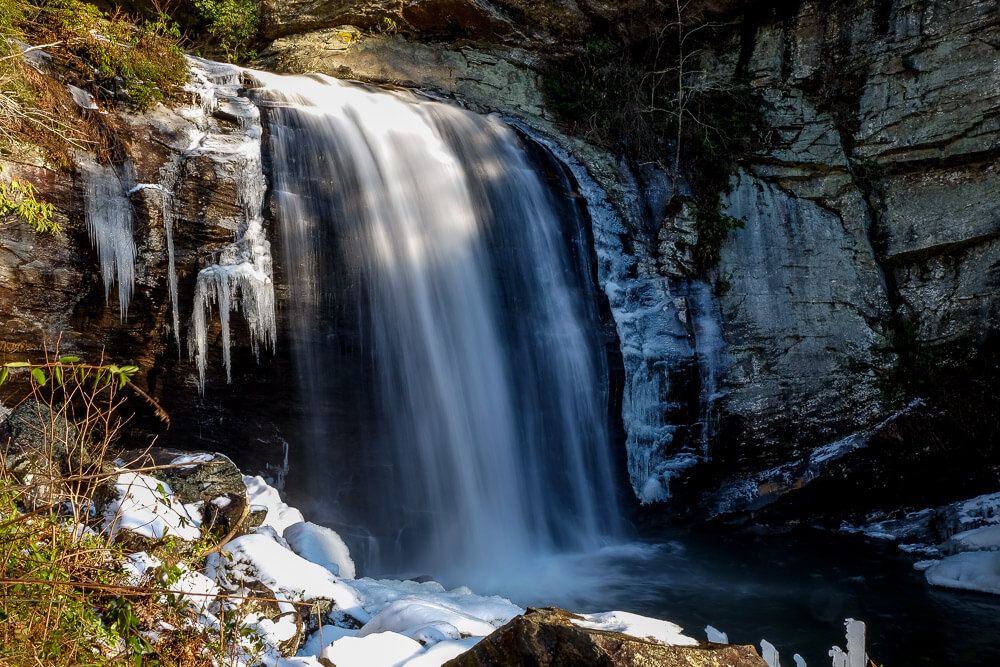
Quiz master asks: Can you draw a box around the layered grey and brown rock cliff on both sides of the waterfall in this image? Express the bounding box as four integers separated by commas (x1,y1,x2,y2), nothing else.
0,0,1000,515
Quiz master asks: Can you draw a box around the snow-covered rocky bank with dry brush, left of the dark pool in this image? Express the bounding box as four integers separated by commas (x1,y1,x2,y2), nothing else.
0,400,764,667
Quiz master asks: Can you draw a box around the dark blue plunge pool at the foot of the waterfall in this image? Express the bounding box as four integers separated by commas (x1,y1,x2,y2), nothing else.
418,529,1000,667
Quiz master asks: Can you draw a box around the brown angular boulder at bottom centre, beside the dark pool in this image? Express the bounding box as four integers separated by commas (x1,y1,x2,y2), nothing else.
445,609,765,667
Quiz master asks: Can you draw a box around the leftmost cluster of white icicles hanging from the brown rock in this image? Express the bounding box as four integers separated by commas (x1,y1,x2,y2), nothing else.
80,159,136,320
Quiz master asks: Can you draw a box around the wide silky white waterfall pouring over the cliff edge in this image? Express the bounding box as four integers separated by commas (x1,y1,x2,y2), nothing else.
252,73,621,572
